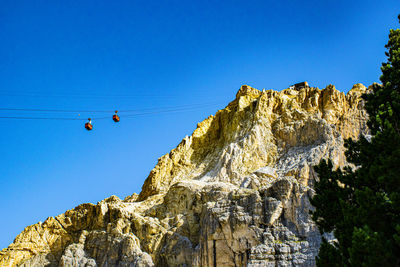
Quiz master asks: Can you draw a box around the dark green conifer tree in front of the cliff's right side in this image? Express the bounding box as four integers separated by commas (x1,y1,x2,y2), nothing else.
311,15,400,266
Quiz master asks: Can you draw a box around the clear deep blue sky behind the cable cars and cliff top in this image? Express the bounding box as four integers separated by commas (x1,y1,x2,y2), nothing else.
0,0,400,248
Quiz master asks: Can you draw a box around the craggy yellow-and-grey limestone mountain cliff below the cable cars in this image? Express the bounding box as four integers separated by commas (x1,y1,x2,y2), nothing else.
0,84,367,266
